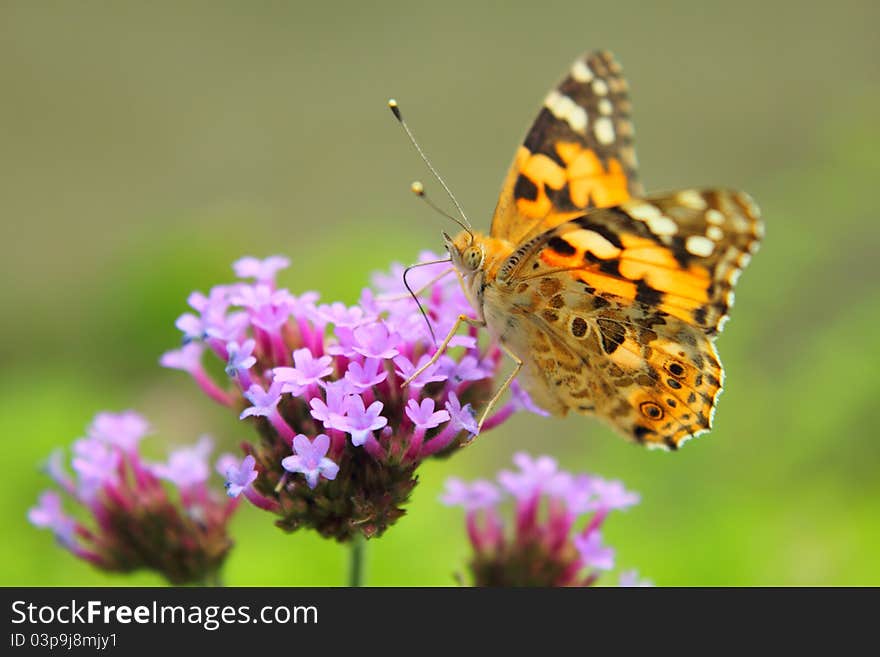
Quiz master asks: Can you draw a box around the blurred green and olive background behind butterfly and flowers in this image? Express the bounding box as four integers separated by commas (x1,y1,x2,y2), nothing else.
0,0,880,585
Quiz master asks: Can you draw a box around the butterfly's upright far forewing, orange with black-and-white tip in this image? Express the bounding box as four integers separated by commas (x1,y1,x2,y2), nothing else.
491,51,642,243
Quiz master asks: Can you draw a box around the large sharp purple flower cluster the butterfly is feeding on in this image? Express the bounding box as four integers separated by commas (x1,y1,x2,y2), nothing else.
161,253,531,540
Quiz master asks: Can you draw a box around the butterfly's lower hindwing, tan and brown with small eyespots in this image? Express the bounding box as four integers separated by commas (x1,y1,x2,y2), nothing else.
496,271,723,449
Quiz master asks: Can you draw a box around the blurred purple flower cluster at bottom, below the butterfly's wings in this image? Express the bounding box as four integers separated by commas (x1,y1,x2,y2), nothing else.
441,452,640,586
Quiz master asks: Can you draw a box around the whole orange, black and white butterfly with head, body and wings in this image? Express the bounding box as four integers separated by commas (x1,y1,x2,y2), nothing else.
447,52,763,449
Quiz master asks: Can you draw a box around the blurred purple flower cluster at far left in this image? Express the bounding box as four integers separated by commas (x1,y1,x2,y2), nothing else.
28,411,237,584
